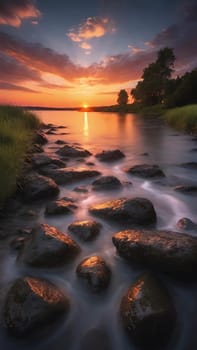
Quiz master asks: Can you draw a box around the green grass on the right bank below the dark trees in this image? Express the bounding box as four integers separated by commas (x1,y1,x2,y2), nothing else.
164,104,197,135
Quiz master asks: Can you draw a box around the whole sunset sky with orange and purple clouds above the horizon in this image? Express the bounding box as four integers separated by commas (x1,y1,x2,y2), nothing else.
0,0,197,107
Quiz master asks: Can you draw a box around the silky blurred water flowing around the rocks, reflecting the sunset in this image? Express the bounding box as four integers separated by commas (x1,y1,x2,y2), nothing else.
0,111,197,350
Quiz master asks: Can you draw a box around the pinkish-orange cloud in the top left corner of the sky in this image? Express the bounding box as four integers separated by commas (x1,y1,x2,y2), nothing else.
0,0,41,27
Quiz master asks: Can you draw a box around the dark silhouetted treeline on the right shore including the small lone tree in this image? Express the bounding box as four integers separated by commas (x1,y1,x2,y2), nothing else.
117,47,197,107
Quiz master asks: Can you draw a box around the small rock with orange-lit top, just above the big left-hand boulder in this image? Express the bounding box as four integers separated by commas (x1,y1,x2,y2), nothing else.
45,199,77,215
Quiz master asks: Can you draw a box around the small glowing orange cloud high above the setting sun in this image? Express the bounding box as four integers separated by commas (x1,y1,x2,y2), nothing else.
67,17,115,42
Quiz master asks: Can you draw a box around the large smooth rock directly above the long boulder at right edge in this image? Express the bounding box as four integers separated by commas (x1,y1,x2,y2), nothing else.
89,197,156,225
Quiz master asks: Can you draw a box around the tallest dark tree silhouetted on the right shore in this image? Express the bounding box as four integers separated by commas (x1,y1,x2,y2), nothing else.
131,47,175,105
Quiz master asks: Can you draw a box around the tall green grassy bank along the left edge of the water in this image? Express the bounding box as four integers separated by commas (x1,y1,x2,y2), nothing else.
0,106,40,206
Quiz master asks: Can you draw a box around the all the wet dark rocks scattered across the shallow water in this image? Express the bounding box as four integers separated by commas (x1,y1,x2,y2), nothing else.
1,124,197,350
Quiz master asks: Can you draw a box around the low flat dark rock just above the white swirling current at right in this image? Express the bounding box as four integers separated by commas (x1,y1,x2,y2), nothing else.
126,164,165,178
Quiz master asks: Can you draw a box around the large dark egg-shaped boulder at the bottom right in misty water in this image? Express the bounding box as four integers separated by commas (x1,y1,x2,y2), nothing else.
120,274,176,349
